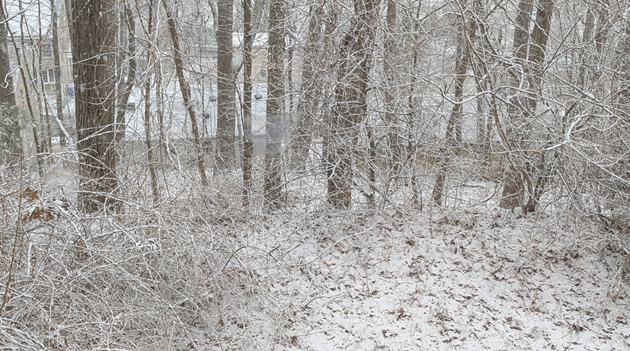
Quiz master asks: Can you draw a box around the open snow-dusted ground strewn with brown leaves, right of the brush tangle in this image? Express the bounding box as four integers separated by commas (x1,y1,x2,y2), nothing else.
216,199,630,350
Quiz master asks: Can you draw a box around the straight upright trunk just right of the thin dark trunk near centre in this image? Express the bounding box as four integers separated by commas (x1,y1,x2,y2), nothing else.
264,0,285,208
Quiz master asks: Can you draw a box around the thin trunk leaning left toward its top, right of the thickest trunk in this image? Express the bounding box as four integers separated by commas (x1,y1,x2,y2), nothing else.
162,0,208,187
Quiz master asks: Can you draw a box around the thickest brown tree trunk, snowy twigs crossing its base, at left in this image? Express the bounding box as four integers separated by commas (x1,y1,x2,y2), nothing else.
72,0,118,212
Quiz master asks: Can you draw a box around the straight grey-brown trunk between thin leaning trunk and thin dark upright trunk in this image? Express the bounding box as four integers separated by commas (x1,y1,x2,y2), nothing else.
216,0,236,169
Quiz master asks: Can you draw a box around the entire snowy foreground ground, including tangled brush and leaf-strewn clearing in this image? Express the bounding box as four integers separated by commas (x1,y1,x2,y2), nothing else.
0,176,630,351
